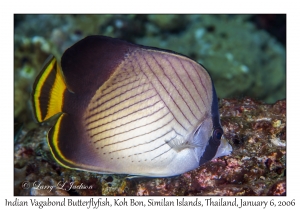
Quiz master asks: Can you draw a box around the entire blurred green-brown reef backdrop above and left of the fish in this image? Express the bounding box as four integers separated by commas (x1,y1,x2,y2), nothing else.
14,14,286,128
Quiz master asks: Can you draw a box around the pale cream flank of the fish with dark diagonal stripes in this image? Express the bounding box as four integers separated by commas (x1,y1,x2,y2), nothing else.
83,49,212,167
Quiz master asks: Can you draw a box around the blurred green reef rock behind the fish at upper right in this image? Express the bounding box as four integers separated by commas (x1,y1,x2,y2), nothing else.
137,15,285,102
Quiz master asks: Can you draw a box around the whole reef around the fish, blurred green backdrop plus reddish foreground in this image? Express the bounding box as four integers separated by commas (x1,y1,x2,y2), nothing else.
14,14,286,195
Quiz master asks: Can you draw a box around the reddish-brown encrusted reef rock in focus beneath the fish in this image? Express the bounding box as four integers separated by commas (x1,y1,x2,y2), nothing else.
14,98,286,196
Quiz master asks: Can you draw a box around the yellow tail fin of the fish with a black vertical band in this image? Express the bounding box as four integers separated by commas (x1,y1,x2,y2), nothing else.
32,56,67,122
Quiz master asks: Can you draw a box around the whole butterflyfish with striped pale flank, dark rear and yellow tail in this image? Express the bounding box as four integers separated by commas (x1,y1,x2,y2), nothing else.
32,36,232,177
